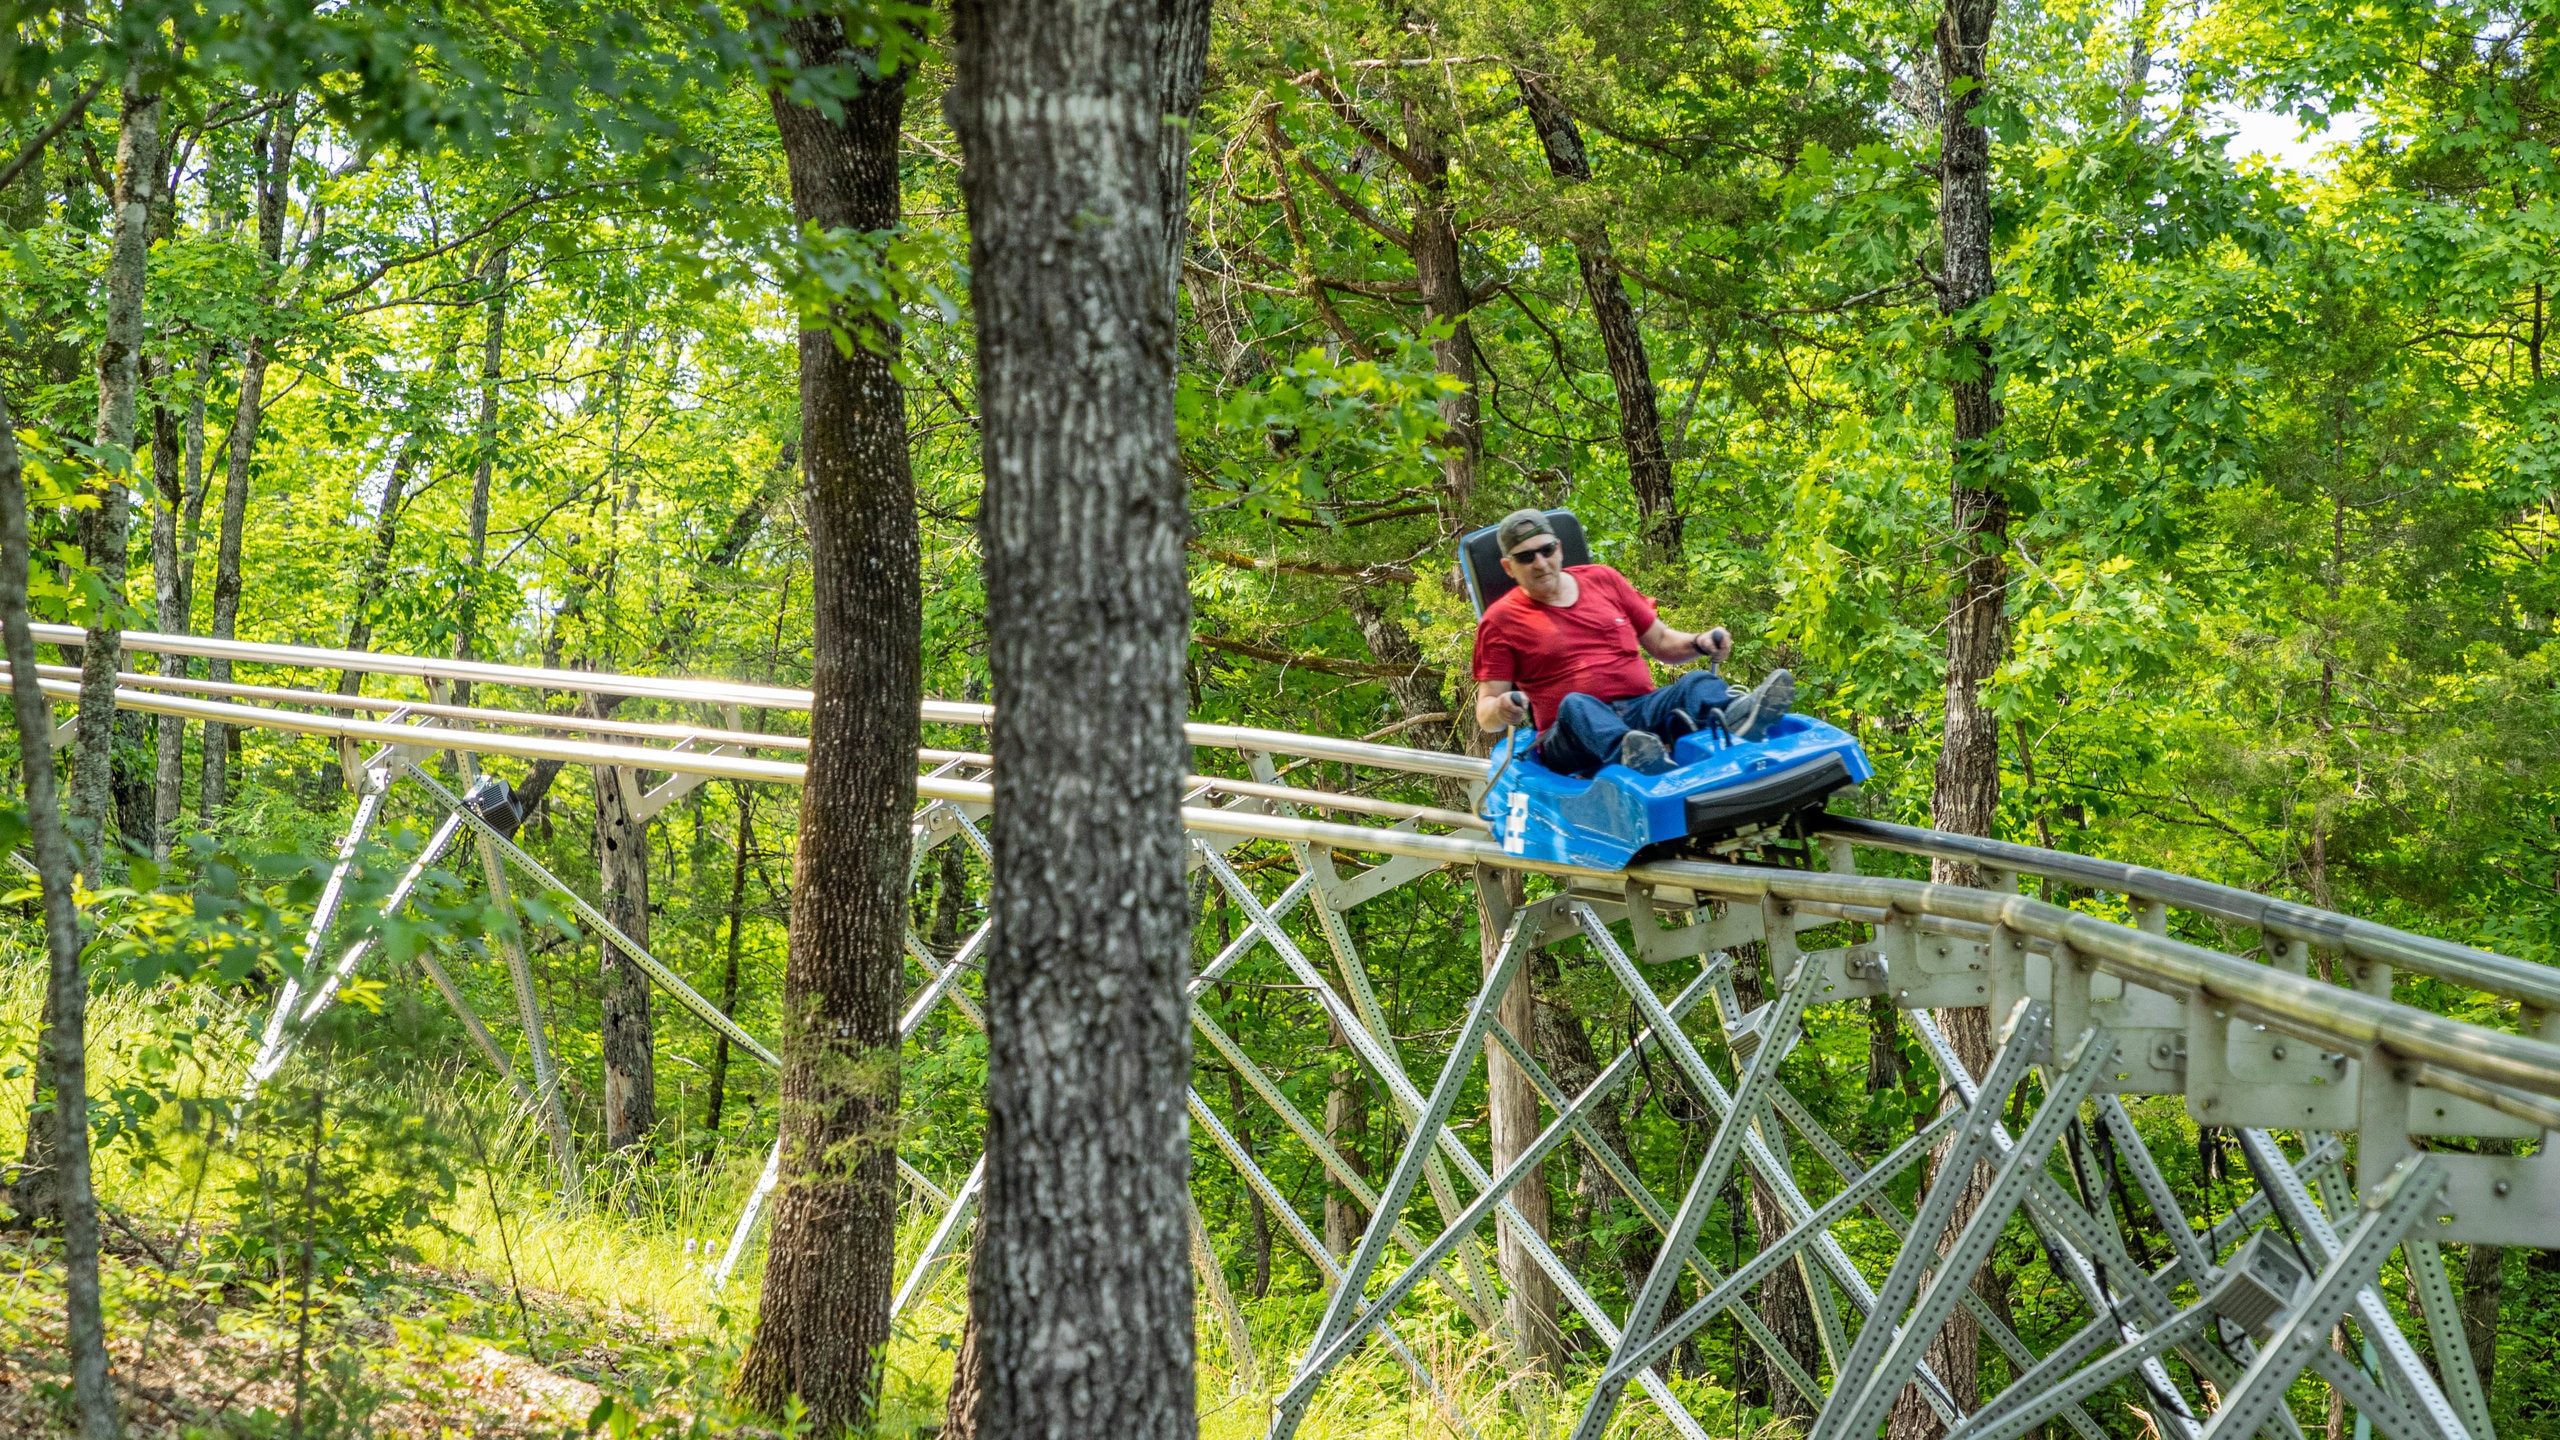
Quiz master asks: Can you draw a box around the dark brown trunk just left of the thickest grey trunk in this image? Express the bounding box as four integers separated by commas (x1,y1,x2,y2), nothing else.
732,25,924,1435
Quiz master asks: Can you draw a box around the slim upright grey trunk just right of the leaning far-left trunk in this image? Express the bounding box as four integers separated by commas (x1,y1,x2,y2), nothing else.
69,83,161,884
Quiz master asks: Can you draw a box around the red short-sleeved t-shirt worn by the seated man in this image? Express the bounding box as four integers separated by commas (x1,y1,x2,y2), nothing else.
1475,566,1654,730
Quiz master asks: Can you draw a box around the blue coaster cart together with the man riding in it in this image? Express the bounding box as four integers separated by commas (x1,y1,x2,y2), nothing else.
1459,510,1874,869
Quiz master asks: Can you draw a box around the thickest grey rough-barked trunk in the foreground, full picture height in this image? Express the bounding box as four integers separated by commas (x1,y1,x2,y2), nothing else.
952,0,1208,1440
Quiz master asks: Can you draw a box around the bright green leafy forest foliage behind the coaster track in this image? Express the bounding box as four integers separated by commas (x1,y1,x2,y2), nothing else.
0,0,2560,1422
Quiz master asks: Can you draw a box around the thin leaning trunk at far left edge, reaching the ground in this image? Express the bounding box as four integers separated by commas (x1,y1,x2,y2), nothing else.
0,384,131,1440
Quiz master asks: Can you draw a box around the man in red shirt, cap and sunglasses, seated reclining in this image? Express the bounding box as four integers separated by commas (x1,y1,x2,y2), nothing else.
1475,510,1795,776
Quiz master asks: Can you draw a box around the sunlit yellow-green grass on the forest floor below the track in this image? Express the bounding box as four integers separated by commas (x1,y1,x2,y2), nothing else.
0,956,1781,1440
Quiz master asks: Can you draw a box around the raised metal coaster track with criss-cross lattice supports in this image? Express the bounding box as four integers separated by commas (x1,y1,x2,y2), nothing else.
36,625,2560,1440
